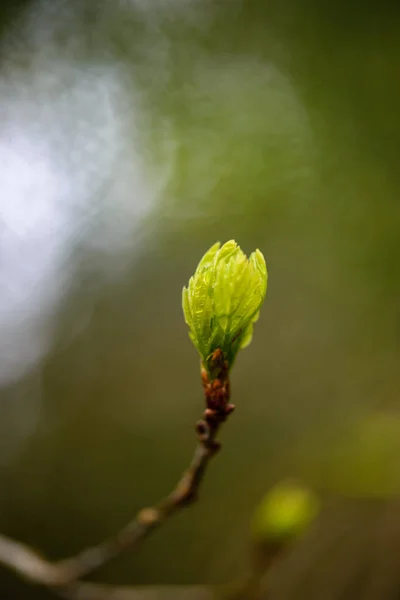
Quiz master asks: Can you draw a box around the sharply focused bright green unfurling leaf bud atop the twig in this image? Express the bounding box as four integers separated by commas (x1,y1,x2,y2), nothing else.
182,240,267,374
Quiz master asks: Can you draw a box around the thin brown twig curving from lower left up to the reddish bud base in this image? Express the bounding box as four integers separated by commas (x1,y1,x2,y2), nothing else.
0,409,230,600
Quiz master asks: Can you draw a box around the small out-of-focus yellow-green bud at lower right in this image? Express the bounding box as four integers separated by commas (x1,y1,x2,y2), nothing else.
252,482,320,543
